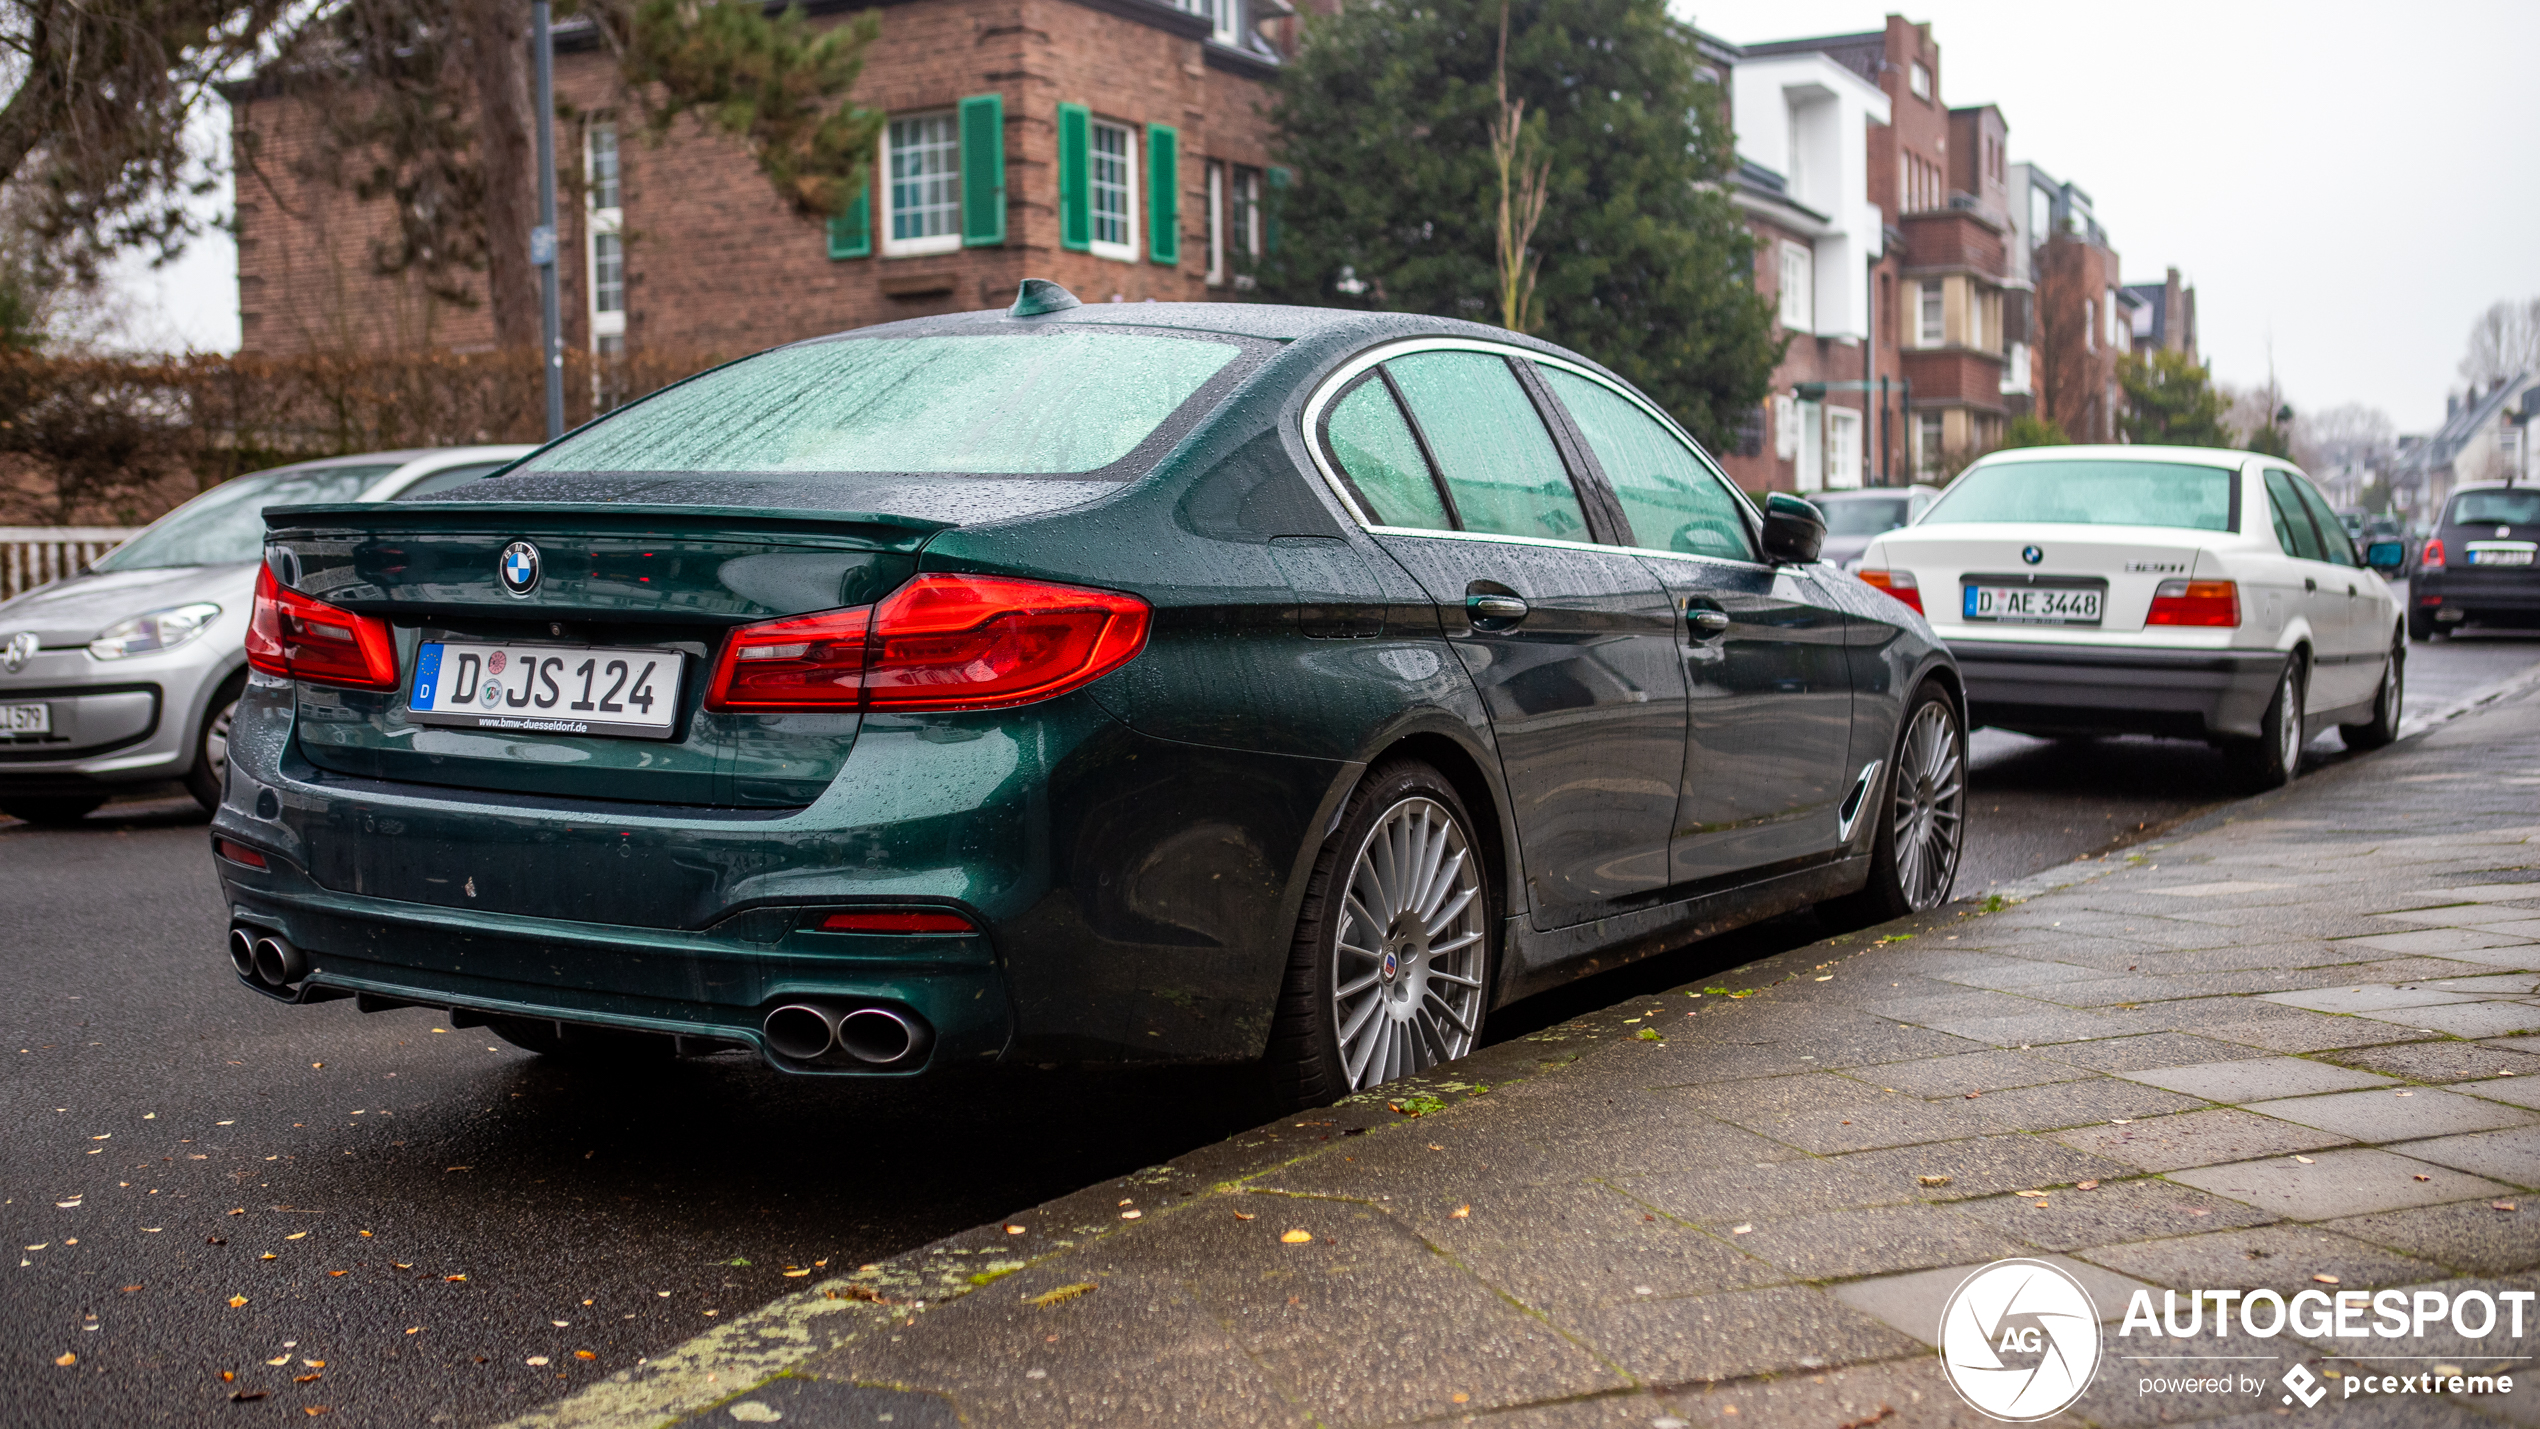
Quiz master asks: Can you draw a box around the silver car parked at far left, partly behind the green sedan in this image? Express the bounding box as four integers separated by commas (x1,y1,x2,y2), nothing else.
0,447,531,825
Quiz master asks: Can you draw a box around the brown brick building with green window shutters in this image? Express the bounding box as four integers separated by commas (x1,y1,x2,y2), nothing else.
234,0,1293,355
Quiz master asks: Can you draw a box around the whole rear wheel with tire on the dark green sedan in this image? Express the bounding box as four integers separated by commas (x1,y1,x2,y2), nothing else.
1267,761,1494,1107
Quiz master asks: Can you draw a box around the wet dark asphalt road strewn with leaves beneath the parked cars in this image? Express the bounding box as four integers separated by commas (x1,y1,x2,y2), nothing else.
0,637,2540,1426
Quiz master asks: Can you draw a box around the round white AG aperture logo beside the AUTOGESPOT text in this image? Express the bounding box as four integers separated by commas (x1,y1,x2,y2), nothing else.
1941,1259,2098,1424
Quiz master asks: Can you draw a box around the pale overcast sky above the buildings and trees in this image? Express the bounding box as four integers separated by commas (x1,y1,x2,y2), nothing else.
109,0,2540,431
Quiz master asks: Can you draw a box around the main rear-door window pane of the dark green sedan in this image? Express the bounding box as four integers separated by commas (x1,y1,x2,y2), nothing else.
1384,353,1588,541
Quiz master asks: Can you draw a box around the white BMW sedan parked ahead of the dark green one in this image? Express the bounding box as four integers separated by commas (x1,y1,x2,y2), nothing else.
1859,447,2408,789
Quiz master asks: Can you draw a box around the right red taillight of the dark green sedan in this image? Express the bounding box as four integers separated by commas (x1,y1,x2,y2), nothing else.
706,576,1148,711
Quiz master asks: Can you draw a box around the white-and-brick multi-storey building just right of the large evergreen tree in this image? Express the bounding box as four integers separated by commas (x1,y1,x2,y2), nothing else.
1717,15,2024,490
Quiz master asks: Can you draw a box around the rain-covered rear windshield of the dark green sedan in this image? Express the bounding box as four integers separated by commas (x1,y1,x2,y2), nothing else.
513,327,1247,477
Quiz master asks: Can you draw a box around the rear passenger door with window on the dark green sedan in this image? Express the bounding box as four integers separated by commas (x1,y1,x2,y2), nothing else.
1321,343,1684,929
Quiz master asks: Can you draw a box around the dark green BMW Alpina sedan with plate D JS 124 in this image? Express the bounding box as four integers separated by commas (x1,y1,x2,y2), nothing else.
211,282,1966,1104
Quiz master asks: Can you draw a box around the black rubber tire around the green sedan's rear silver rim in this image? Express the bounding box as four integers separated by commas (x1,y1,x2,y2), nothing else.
1262,759,1499,1112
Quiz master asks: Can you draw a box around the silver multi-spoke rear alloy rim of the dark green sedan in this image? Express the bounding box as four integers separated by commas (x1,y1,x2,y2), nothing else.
1331,797,1488,1091
